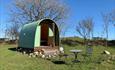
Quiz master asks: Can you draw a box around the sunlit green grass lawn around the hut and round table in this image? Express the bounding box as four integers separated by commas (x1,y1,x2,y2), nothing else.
0,45,115,70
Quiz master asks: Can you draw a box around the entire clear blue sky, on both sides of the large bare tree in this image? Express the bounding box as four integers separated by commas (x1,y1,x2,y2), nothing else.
0,0,115,39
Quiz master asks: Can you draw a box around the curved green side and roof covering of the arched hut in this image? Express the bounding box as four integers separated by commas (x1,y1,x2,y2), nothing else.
19,21,38,48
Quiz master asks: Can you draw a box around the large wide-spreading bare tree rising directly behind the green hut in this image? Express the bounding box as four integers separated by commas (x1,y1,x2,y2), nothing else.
8,0,67,40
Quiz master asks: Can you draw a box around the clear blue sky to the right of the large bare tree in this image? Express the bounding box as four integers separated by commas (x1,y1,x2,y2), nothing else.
65,0,115,39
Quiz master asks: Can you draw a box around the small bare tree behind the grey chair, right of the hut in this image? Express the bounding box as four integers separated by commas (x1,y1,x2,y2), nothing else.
76,18,94,45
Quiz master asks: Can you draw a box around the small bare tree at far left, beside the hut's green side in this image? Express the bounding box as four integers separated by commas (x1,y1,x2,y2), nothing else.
5,12,20,41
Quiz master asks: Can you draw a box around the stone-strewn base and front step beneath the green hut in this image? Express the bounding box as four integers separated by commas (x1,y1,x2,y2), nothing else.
18,46,59,56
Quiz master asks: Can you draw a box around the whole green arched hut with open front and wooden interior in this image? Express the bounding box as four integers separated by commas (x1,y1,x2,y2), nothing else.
18,19,59,51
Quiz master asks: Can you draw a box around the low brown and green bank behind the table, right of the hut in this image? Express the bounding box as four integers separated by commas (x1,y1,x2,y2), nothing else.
61,37,115,46
